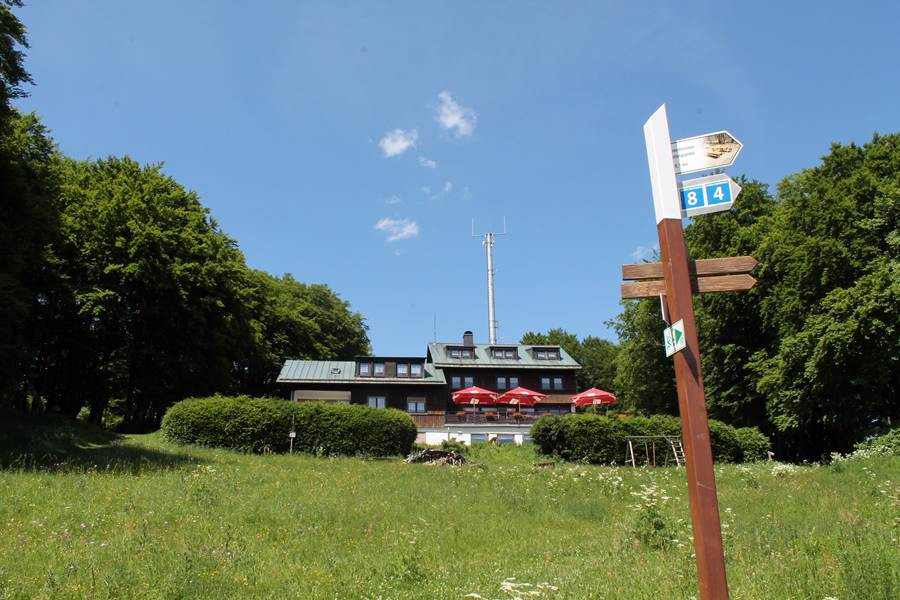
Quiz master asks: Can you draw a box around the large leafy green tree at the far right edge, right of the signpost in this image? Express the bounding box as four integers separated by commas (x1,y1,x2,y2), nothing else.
749,134,900,459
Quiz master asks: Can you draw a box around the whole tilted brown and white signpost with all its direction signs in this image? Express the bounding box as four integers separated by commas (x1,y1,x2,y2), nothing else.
622,105,756,600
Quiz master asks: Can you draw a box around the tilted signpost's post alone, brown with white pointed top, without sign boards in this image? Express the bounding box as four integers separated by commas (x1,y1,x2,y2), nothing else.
644,105,728,600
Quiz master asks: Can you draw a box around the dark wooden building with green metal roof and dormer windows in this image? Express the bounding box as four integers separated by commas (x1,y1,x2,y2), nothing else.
278,331,581,443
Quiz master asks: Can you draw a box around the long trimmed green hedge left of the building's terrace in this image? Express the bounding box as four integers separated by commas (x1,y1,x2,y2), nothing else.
162,396,416,456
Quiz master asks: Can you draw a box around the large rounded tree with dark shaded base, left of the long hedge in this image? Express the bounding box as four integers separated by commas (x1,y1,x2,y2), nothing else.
35,158,244,428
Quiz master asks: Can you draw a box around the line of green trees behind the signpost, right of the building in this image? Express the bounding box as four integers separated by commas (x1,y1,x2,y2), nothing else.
523,134,900,460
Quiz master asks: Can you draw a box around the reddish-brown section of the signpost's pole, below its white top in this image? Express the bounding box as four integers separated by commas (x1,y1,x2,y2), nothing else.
657,219,728,600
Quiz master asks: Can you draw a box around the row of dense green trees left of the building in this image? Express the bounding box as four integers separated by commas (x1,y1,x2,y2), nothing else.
0,0,370,430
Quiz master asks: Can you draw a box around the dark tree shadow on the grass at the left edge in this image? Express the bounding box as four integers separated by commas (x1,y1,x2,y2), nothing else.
0,412,206,473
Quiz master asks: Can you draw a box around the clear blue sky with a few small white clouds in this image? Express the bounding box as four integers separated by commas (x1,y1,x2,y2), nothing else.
16,0,900,358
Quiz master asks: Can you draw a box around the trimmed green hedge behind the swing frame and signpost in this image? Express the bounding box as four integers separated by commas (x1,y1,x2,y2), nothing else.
531,414,769,464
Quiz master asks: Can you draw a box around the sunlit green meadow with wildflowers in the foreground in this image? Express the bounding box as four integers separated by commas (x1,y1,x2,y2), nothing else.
0,414,900,600
